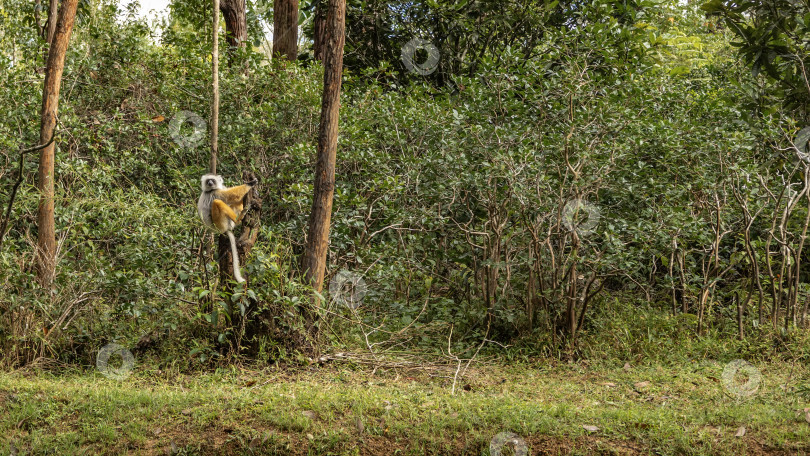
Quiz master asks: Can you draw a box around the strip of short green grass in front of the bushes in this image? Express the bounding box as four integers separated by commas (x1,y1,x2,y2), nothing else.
0,361,810,455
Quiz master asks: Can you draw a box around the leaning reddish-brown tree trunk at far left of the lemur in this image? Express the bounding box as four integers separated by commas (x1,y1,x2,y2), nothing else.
37,0,79,286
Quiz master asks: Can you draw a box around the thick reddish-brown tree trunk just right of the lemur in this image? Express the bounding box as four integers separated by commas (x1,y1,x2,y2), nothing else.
303,0,346,331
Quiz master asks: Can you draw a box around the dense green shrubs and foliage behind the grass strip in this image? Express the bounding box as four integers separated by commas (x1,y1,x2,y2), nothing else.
0,0,810,370
